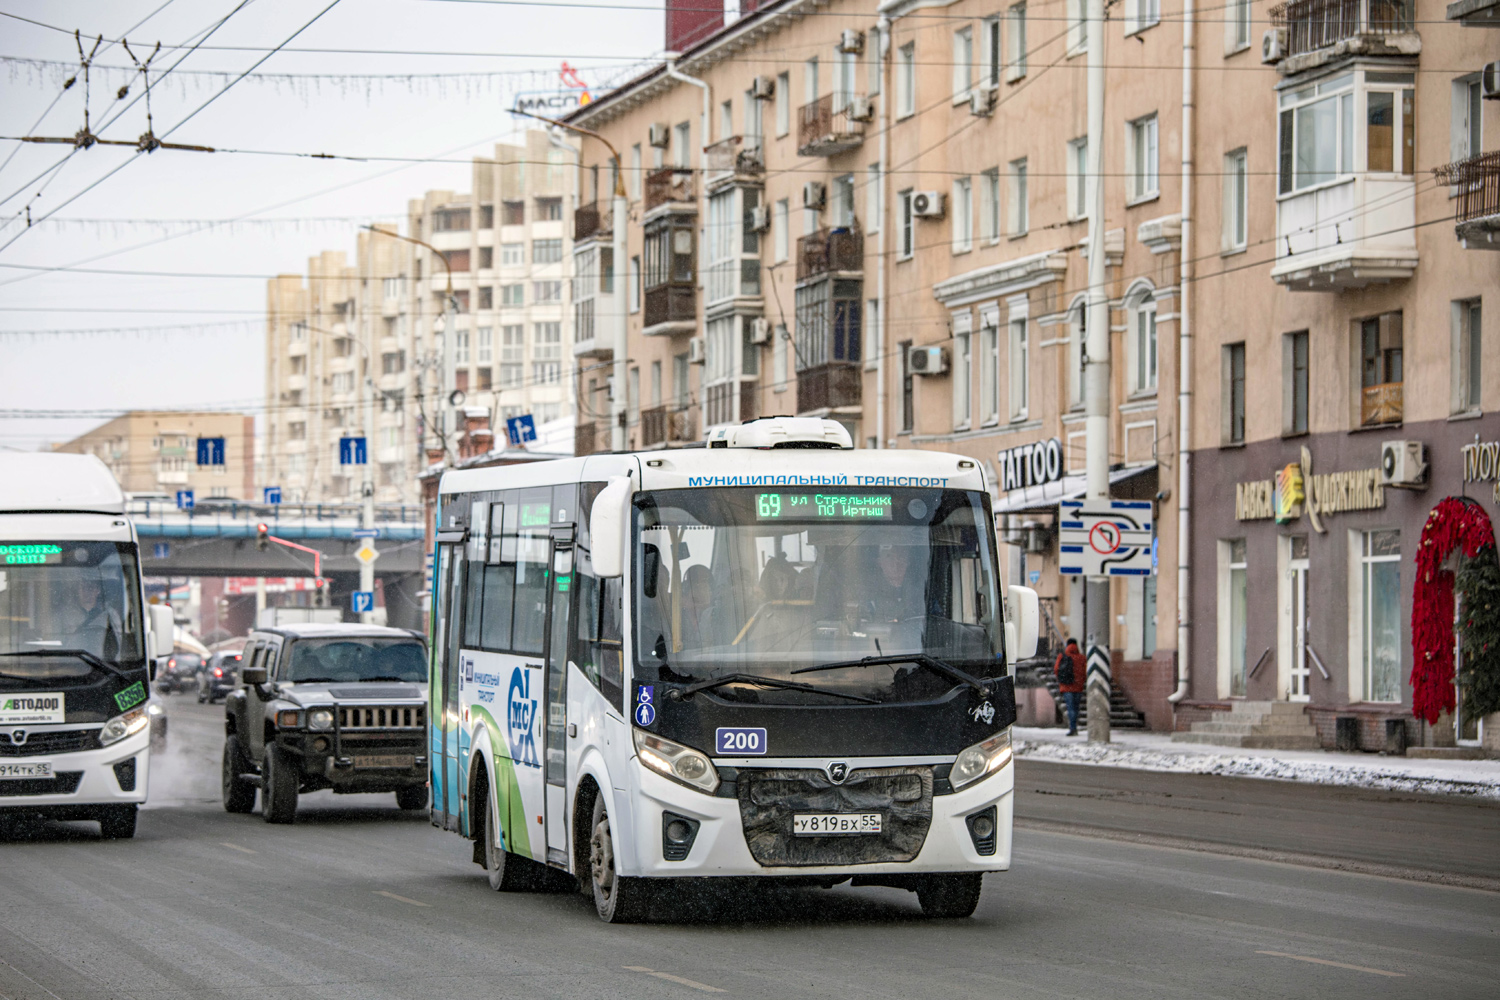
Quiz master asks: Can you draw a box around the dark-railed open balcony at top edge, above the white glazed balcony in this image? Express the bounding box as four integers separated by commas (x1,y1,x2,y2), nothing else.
1271,0,1422,76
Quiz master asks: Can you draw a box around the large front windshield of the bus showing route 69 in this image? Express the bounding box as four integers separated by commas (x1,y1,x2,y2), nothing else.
633,489,1005,703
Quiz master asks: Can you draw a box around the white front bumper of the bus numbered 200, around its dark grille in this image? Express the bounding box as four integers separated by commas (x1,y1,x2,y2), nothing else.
621,760,1016,877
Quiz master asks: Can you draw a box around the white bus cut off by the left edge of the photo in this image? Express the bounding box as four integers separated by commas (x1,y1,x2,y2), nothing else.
0,453,173,840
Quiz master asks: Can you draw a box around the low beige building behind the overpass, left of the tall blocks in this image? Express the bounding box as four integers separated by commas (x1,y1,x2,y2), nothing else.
53,409,255,501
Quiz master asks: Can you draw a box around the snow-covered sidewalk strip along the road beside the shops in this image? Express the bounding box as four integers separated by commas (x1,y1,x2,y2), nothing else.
1013,726,1500,801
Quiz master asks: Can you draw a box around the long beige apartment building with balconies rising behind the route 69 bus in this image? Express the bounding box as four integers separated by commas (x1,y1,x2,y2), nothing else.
570,0,1500,738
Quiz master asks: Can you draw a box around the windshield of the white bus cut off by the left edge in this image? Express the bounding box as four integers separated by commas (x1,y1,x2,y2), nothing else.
0,541,146,687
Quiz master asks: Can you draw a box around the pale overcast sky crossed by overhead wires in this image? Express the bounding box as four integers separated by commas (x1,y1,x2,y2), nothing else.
0,0,663,450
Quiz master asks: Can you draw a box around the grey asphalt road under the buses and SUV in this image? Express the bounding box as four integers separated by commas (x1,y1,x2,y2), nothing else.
0,697,1500,1000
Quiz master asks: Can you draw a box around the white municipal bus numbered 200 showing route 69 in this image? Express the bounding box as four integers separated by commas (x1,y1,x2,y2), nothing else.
429,418,1037,922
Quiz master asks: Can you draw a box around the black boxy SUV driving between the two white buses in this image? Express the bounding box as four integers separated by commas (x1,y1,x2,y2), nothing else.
224,624,428,823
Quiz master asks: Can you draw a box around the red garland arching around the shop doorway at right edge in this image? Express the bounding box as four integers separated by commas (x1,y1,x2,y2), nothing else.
1412,496,1496,724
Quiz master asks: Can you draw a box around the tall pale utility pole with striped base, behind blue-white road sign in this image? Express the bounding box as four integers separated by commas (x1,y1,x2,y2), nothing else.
1083,0,1110,744
